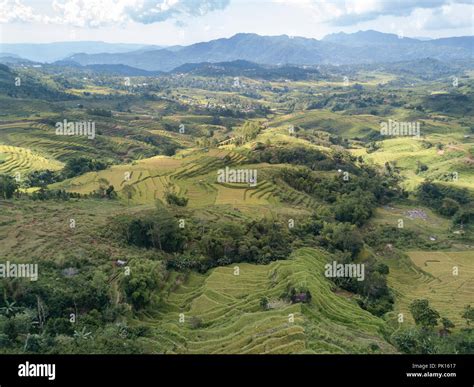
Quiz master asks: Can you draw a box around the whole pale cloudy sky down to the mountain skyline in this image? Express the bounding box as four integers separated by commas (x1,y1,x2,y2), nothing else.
0,0,474,45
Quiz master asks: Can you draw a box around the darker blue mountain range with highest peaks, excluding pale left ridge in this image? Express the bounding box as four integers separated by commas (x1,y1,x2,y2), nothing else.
57,31,474,71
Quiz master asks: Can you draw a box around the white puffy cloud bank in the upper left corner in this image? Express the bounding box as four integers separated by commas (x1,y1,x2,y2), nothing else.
0,0,230,27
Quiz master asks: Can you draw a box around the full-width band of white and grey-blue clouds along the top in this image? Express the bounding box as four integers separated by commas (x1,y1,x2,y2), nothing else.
0,0,474,30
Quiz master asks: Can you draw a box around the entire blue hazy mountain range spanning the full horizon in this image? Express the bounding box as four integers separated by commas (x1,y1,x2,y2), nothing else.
0,30,474,72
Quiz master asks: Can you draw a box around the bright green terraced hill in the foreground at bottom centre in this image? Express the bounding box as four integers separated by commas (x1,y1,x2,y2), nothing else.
137,248,394,353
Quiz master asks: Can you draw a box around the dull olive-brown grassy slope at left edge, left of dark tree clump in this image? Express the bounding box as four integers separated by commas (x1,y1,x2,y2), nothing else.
0,200,142,264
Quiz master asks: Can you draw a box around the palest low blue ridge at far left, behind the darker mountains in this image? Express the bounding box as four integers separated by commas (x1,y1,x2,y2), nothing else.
0,41,158,62
